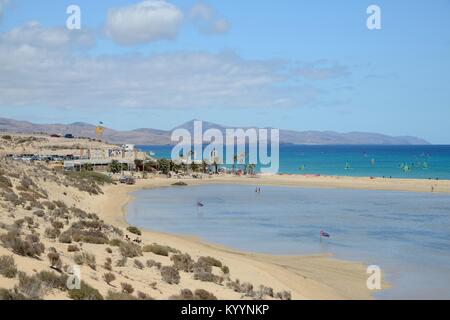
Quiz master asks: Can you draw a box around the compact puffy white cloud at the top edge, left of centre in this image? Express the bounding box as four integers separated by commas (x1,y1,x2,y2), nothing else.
106,0,183,46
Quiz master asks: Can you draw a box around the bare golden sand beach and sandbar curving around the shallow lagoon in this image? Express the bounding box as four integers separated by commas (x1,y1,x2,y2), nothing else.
88,175,450,299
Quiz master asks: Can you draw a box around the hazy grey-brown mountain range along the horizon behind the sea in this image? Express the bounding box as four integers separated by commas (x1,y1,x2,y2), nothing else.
0,118,430,145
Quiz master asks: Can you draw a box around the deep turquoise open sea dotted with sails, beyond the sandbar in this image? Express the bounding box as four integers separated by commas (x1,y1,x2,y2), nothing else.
139,145,450,179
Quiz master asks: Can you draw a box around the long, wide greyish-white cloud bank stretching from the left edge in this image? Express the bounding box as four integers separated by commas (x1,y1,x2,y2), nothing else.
0,23,352,112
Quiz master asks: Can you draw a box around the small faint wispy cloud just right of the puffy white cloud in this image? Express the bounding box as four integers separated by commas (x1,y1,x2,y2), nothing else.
189,2,230,34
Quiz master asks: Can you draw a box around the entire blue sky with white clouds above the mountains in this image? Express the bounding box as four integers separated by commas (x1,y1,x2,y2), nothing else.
0,0,450,143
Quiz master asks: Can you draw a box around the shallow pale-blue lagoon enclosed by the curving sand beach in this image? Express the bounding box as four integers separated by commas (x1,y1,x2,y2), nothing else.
126,185,450,299
